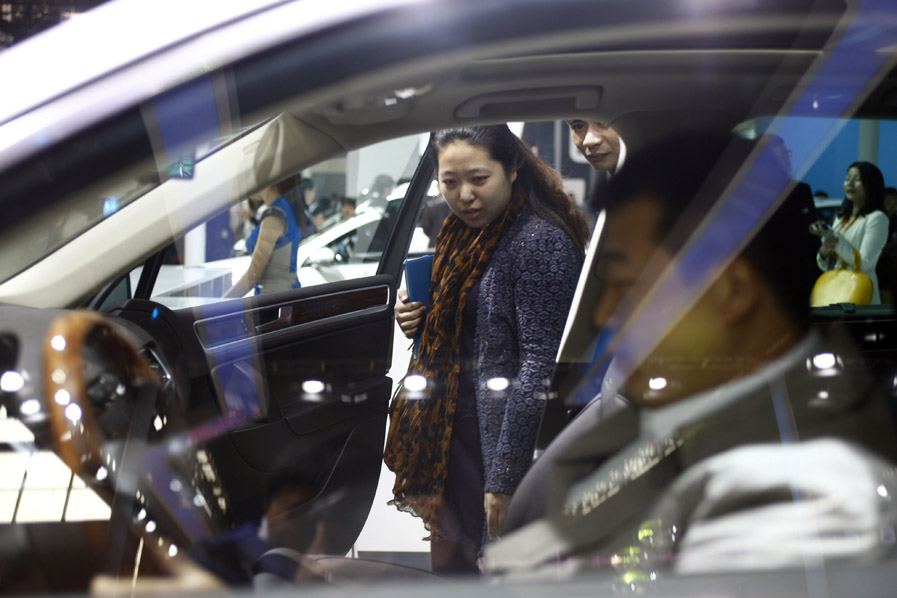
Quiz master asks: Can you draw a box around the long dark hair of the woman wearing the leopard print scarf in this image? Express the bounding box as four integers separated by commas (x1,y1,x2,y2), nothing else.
431,125,589,259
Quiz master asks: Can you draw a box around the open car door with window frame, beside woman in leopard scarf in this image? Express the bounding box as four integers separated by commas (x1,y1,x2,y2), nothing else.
89,144,432,555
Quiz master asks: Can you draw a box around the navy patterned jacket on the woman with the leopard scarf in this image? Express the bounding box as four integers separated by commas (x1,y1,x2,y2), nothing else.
476,207,580,502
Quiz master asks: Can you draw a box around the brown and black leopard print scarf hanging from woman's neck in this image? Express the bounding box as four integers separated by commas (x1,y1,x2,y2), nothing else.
383,192,525,540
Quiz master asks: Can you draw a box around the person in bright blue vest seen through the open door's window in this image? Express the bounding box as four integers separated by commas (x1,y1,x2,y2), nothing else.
224,179,302,297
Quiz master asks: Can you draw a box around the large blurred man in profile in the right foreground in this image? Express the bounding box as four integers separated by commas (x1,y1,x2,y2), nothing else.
486,133,897,580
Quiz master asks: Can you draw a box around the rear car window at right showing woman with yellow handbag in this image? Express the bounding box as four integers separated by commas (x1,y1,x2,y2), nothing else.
739,116,897,311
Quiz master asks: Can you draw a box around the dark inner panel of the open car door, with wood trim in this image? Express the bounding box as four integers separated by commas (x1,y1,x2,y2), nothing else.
103,275,396,554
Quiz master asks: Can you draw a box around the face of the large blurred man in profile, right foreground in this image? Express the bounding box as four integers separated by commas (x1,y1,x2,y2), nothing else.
593,196,725,405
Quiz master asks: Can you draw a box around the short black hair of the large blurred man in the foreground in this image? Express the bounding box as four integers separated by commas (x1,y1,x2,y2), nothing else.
592,132,816,324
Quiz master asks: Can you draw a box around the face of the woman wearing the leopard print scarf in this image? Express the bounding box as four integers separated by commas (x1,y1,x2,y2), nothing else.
437,141,517,228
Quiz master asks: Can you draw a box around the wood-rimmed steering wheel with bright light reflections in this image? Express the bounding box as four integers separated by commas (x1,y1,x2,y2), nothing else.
42,311,166,571
